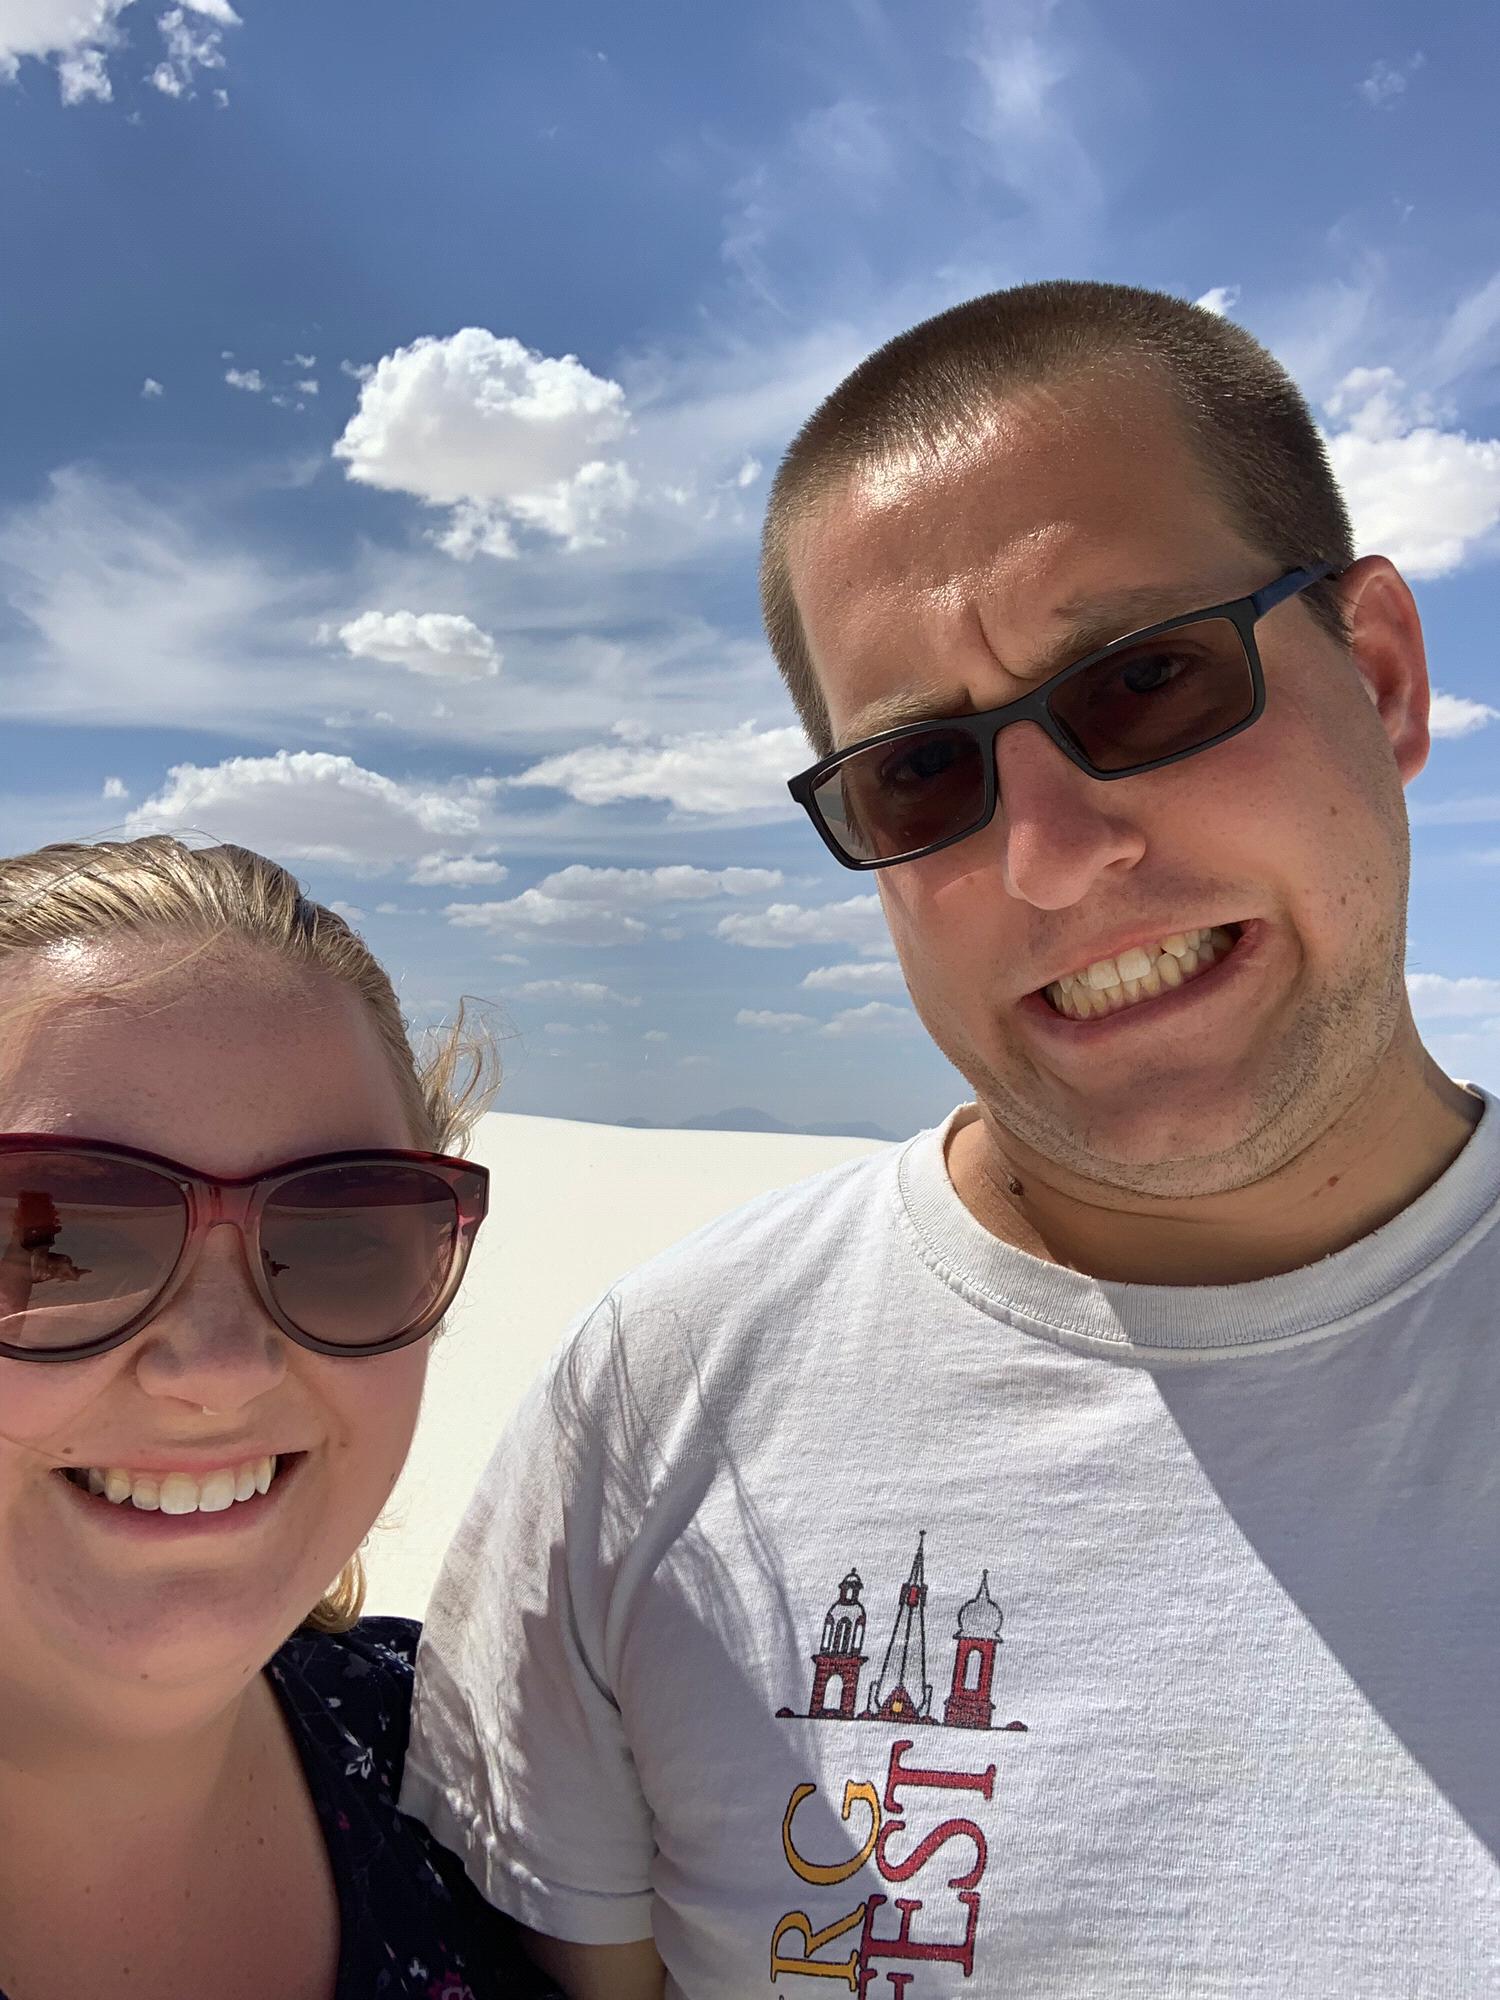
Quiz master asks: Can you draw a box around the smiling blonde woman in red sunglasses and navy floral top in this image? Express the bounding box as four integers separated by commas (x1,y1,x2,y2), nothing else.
0,838,556,2000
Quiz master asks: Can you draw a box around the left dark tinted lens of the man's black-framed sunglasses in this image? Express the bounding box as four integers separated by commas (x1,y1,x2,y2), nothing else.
812,728,986,862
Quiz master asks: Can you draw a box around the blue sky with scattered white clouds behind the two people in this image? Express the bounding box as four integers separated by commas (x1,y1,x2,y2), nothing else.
0,0,1500,1132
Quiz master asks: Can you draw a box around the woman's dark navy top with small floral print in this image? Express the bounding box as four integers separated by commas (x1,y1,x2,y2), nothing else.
266,1618,560,2000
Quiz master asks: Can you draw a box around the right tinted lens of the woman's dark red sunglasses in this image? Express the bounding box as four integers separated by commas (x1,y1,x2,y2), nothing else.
260,1160,458,1348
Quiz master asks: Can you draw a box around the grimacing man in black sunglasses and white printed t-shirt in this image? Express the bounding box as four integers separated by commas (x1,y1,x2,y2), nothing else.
408,284,1500,2000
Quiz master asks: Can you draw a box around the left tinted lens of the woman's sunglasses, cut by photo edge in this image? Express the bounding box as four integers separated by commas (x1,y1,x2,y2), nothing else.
0,1152,188,1352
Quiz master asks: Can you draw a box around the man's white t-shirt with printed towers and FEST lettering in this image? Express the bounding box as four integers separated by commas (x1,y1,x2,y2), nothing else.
402,1100,1500,2000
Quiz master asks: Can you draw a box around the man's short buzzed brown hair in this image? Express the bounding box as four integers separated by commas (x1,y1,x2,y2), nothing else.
760,280,1354,756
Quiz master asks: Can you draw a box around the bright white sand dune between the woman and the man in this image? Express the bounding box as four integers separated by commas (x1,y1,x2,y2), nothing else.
366,1112,892,1618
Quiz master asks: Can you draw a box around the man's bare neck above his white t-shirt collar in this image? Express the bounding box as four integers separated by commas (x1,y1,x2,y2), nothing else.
948,1038,1482,1284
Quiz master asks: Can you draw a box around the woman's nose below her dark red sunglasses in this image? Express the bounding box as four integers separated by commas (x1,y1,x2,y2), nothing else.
136,1224,288,1416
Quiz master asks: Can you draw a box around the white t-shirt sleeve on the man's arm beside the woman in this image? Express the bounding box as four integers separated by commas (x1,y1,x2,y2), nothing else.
402,1298,654,1944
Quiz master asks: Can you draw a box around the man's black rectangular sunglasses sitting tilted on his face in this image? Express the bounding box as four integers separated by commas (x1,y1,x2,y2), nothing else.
788,562,1334,868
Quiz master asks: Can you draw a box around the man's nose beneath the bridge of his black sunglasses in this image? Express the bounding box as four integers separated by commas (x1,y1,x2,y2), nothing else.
994,722,1146,910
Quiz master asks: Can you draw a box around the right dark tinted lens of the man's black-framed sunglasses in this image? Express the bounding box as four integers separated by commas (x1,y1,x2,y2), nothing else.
1048,618,1256,770
